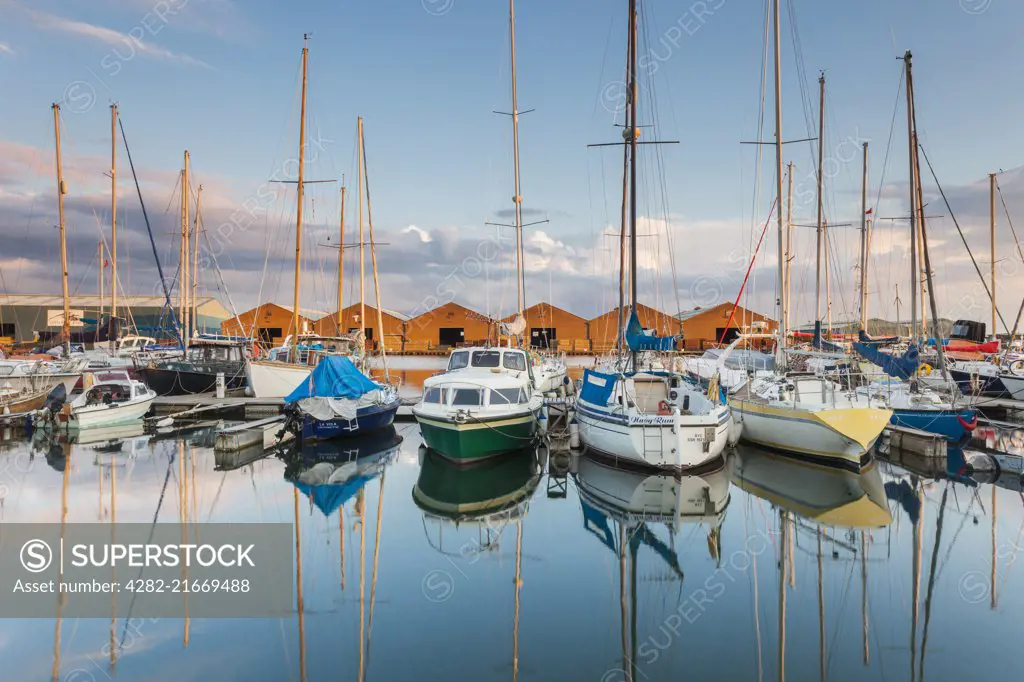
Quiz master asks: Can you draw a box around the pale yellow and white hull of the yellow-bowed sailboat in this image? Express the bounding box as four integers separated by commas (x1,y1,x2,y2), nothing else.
729,399,892,472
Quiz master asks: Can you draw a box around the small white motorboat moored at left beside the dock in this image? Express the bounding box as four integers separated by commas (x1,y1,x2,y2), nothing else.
37,370,157,429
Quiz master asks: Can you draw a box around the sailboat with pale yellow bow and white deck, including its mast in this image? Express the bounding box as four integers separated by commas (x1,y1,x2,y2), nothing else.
719,0,892,471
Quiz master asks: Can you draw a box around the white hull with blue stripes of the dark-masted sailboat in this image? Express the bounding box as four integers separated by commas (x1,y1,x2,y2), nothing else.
577,400,732,470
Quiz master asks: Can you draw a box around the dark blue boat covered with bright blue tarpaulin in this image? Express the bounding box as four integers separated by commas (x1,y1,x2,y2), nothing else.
285,355,401,441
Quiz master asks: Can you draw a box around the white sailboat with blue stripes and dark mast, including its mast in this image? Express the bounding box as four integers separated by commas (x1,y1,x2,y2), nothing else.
577,0,731,470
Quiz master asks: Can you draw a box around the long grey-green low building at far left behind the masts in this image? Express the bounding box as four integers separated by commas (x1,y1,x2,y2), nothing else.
0,294,230,343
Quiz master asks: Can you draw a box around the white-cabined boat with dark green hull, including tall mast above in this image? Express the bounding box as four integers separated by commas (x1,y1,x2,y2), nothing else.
413,0,565,463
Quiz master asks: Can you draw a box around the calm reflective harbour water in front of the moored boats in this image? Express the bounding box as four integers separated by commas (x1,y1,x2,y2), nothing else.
0,413,1024,682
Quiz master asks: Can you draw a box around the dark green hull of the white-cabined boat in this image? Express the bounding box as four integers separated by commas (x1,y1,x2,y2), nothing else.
413,409,539,464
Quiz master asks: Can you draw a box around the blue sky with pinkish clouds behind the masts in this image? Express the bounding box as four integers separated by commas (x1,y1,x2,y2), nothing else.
0,0,1024,329
